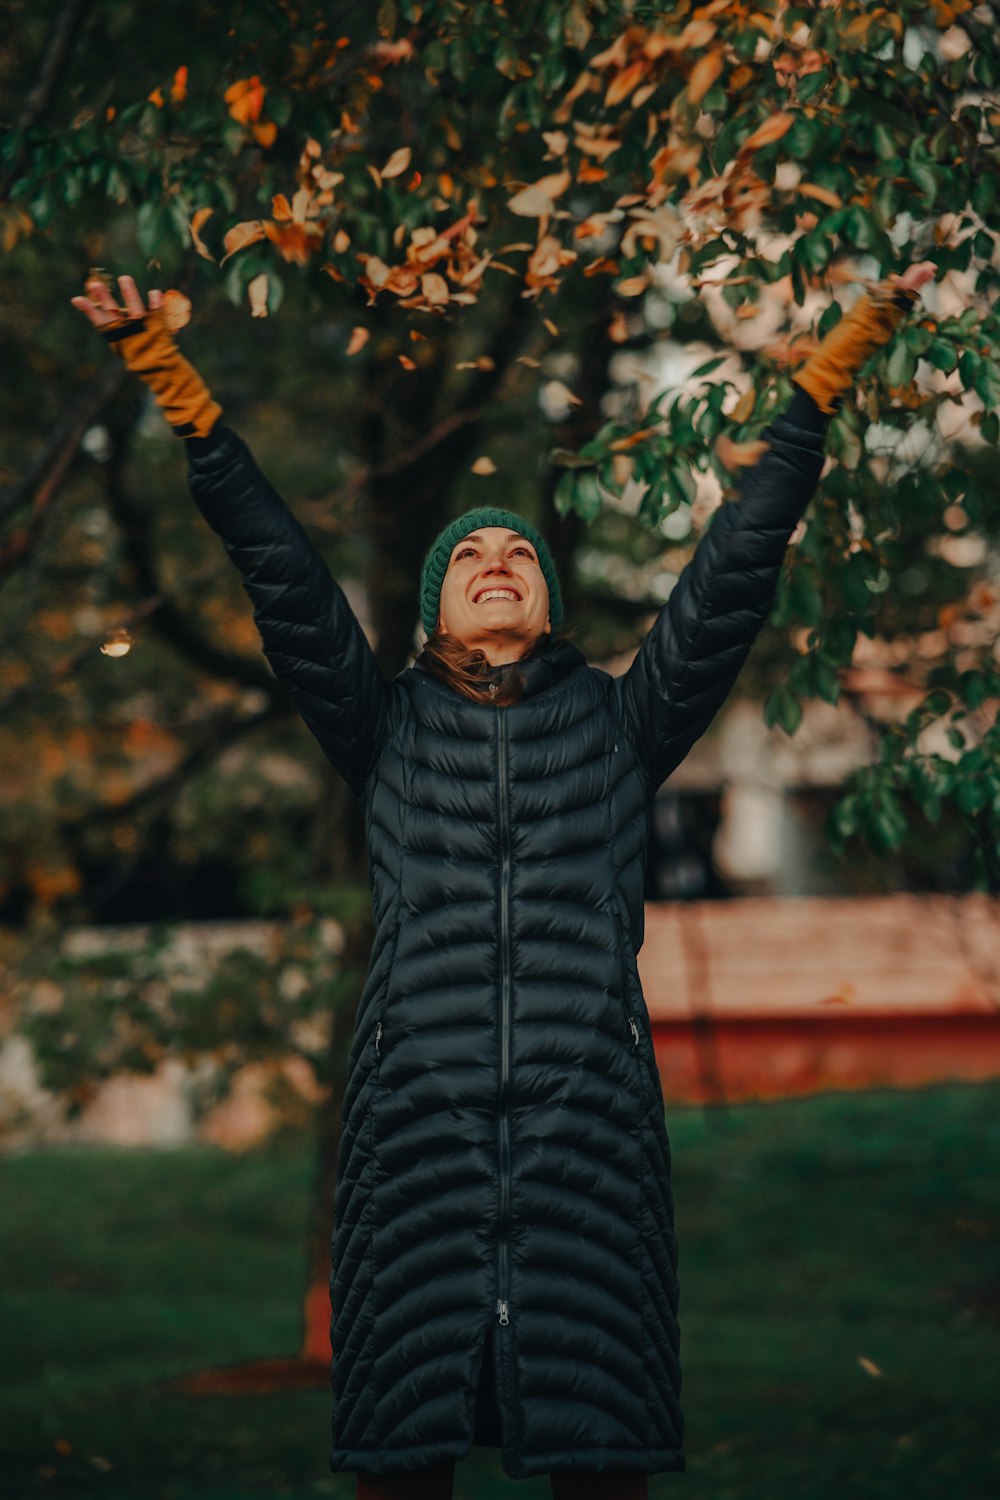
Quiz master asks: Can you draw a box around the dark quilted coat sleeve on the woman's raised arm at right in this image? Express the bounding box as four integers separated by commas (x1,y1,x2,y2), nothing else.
619,387,829,786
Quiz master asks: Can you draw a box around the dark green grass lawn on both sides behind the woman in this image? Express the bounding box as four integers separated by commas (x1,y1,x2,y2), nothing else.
0,1083,1000,1500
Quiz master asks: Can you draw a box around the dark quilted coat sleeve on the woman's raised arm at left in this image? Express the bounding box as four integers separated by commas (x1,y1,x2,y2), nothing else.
184,425,390,798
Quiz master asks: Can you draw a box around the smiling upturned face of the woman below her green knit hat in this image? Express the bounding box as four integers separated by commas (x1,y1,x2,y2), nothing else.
438,527,552,665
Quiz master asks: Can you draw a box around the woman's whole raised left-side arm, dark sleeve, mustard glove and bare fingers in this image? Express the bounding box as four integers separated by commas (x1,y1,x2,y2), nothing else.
73,278,390,798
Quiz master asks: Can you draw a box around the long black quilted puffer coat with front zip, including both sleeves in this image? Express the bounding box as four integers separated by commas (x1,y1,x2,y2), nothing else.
189,392,826,1478
